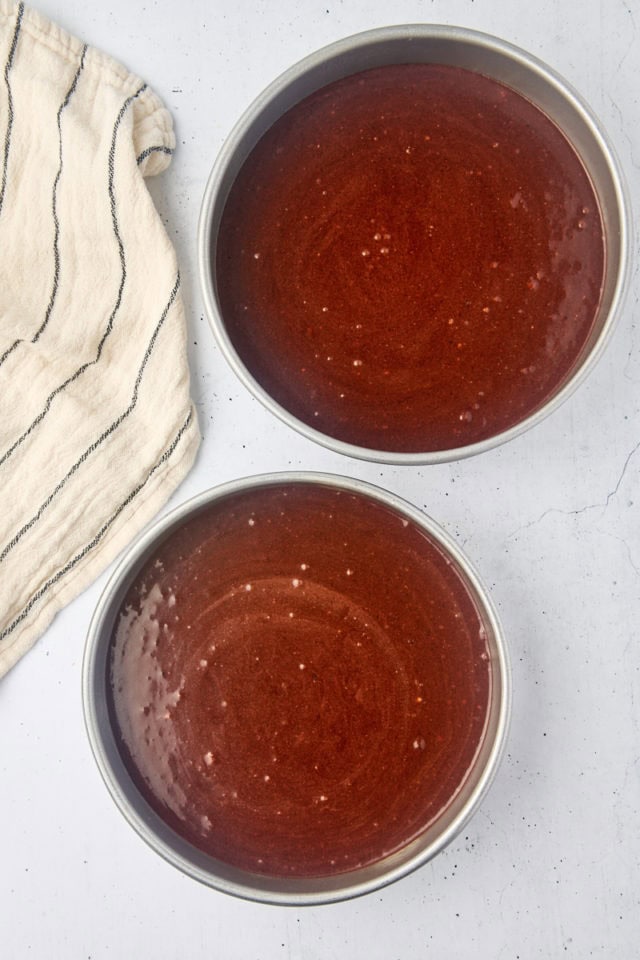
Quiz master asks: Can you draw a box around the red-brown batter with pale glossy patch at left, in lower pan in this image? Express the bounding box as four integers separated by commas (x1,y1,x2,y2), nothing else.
111,484,491,876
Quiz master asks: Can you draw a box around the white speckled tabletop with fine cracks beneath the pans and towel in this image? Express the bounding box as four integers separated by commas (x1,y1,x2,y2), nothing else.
0,0,640,960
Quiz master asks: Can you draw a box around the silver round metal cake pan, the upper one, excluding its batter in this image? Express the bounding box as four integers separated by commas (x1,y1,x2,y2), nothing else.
198,24,629,464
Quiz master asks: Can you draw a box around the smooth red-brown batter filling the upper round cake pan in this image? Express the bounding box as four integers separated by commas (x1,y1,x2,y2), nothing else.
214,64,604,452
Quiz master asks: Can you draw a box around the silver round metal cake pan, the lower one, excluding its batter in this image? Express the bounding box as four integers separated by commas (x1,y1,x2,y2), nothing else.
83,473,511,906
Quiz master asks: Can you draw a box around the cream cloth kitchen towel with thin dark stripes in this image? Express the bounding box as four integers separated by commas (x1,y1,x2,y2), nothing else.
0,0,200,676
